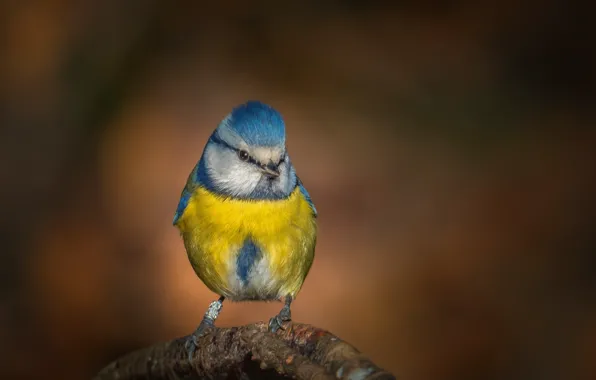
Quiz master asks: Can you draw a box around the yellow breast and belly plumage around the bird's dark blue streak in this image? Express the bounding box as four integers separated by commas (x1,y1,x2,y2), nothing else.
176,187,317,300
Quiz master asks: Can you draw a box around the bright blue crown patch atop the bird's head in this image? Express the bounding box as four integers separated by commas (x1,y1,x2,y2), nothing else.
223,101,286,146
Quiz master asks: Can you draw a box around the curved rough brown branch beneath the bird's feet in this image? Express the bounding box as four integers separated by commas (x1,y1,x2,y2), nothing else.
95,322,395,380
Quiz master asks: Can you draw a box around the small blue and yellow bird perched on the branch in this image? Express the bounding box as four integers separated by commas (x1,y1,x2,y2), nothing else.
173,100,318,358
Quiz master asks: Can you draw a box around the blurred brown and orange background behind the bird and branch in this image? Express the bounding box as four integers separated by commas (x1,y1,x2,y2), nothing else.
0,0,596,380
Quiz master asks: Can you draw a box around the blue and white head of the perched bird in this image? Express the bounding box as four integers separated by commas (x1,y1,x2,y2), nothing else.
196,101,296,199
